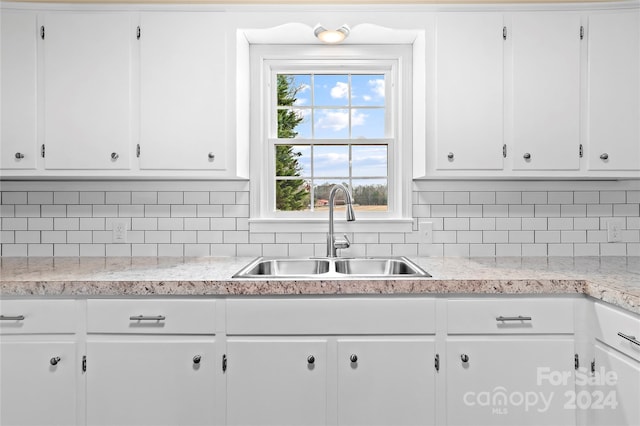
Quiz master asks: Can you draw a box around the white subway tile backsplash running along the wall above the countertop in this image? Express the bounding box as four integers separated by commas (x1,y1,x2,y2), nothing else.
0,182,640,257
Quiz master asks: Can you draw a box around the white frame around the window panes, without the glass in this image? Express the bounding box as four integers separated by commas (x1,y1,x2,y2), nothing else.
249,44,413,232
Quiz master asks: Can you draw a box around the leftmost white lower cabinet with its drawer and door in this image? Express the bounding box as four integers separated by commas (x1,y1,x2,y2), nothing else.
0,299,80,426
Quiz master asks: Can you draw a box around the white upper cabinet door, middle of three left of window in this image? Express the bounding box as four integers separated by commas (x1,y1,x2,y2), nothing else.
43,12,134,170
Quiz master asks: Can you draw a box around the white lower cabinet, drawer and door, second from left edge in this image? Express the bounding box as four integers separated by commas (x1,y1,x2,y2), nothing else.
84,299,223,426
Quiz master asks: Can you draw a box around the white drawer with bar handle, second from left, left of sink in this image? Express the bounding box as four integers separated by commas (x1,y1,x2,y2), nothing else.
87,299,216,334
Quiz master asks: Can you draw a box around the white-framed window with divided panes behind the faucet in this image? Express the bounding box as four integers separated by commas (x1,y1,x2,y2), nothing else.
251,46,411,231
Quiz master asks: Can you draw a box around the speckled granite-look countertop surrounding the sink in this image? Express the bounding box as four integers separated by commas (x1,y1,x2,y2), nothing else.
0,257,640,314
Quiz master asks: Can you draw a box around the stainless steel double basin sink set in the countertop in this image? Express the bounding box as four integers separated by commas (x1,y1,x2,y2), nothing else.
233,257,431,279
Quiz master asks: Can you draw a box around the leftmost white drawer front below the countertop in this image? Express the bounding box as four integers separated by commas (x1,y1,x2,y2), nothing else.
0,300,77,334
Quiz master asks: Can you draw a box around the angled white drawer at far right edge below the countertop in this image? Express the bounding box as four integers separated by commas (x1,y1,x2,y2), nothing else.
595,302,640,361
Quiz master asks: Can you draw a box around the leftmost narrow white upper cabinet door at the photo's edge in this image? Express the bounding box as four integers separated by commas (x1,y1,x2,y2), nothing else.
0,10,37,169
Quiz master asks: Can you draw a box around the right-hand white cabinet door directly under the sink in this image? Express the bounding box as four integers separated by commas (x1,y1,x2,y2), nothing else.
337,338,435,426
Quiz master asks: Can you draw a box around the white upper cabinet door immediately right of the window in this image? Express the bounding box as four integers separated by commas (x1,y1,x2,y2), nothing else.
436,13,504,170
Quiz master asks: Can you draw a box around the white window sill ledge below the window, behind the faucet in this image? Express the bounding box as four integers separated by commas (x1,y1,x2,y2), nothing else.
249,218,413,232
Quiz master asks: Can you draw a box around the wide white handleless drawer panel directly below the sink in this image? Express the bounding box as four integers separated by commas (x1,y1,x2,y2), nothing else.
227,298,435,335
